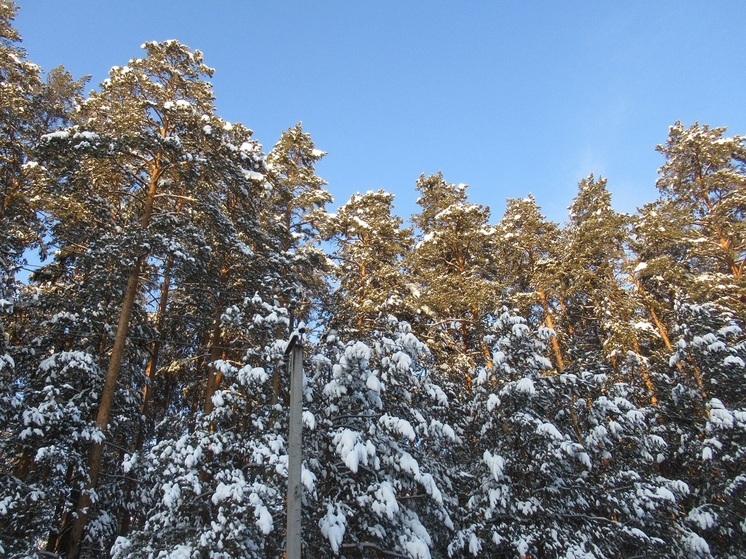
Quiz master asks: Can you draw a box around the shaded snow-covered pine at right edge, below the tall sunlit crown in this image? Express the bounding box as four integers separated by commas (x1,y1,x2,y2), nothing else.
657,301,746,557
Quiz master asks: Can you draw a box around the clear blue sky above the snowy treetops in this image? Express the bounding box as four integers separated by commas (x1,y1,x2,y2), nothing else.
16,0,746,222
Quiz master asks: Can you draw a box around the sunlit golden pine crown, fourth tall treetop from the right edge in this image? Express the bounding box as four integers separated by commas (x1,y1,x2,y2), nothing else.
405,173,497,385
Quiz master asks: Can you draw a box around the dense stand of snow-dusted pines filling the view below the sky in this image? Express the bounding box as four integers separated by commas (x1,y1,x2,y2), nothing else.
0,1,746,559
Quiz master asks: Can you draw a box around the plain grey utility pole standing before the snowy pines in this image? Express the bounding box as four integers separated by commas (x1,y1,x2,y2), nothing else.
285,328,304,559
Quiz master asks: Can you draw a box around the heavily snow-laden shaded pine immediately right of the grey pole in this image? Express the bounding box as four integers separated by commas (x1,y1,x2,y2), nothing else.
304,317,454,559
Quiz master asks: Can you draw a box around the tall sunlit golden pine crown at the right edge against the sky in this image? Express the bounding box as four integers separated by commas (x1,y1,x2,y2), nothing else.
648,122,746,313
